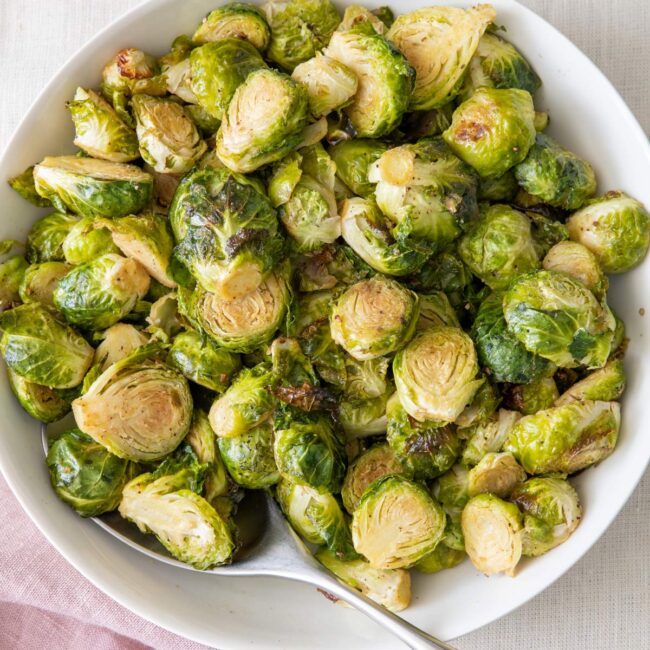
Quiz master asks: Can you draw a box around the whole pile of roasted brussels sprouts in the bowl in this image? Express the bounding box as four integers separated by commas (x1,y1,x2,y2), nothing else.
0,0,650,610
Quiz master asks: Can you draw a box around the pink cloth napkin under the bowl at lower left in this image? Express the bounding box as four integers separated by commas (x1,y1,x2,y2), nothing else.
0,475,207,650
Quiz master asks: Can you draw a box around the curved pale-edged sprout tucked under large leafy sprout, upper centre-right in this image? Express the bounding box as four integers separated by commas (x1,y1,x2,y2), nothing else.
341,195,428,276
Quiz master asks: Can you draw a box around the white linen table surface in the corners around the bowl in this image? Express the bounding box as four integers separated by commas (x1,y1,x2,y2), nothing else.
0,0,650,650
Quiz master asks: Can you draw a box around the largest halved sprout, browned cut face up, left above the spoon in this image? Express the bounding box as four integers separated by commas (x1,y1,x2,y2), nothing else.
72,345,192,462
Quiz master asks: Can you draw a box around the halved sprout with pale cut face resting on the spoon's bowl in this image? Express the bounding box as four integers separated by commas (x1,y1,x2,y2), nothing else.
119,454,236,569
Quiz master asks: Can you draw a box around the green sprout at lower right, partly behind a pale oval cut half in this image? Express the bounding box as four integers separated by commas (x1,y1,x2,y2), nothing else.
510,477,582,557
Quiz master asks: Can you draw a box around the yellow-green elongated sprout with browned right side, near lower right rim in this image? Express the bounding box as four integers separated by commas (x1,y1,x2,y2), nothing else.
504,400,621,474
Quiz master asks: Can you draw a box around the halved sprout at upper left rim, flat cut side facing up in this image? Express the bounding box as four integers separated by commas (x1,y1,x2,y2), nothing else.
34,156,153,217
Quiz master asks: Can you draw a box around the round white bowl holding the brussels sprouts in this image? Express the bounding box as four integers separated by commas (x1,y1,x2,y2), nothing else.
0,0,650,650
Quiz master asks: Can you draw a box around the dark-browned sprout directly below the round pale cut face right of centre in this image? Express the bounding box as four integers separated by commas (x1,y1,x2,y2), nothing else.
386,394,460,481
